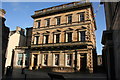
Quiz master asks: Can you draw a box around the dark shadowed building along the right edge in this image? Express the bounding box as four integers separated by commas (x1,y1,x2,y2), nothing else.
102,1,120,80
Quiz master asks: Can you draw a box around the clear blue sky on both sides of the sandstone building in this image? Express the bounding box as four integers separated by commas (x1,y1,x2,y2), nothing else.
2,2,106,54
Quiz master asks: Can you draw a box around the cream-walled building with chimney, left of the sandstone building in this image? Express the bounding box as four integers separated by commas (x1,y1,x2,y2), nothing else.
5,27,25,67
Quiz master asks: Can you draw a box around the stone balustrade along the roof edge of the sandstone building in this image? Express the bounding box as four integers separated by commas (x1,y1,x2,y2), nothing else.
35,0,86,14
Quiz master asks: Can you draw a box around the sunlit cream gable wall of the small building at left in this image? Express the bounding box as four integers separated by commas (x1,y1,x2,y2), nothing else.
5,32,25,67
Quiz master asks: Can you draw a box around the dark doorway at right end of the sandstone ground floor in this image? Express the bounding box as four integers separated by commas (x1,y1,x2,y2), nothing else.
80,54,87,72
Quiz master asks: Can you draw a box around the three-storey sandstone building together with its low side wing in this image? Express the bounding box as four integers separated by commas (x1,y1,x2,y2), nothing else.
14,2,97,73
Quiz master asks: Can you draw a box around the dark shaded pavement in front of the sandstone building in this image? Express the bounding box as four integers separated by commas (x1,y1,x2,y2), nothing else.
3,68,107,80
